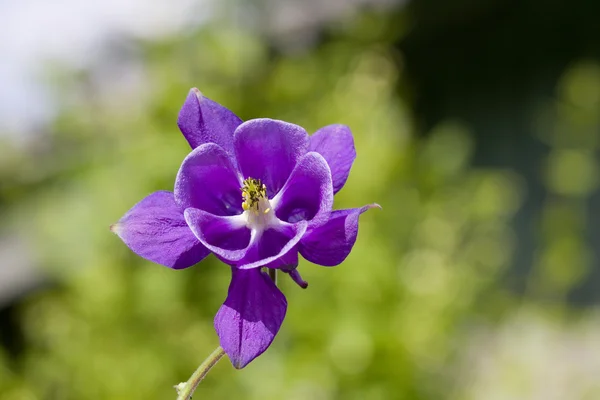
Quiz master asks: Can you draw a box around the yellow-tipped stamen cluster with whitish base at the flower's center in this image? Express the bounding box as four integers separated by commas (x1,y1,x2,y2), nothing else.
241,178,275,231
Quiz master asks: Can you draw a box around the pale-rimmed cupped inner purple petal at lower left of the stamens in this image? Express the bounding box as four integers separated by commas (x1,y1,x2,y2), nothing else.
184,208,251,264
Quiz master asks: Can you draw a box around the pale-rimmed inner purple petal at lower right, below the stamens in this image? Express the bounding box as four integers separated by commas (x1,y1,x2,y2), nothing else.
237,221,308,269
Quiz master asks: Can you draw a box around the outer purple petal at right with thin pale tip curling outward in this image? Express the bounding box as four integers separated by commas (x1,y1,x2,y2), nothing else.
299,204,381,267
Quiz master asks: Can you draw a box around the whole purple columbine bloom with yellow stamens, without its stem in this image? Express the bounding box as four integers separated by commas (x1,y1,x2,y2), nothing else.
112,89,375,368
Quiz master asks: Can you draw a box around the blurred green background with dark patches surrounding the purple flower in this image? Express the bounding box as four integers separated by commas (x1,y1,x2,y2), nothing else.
0,0,600,400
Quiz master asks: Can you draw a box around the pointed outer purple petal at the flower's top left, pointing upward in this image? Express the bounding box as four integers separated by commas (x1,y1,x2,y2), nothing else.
177,88,242,157
